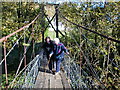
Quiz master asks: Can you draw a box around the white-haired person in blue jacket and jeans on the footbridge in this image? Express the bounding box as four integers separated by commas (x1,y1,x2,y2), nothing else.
49,38,69,74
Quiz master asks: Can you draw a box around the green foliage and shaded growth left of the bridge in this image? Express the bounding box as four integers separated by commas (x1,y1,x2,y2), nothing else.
0,2,47,88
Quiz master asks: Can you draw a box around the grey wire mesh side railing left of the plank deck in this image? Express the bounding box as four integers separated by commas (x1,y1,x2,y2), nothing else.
9,49,45,88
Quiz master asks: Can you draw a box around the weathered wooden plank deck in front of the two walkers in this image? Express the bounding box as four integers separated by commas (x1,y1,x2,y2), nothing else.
35,69,71,89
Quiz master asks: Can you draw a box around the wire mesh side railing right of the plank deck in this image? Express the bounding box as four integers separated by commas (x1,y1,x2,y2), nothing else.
62,55,101,89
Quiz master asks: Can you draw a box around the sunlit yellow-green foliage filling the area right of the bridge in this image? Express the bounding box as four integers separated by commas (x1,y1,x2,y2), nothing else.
60,2,120,89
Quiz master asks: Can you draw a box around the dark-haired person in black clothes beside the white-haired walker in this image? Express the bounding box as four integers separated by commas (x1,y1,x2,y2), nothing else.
43,37,53,73
